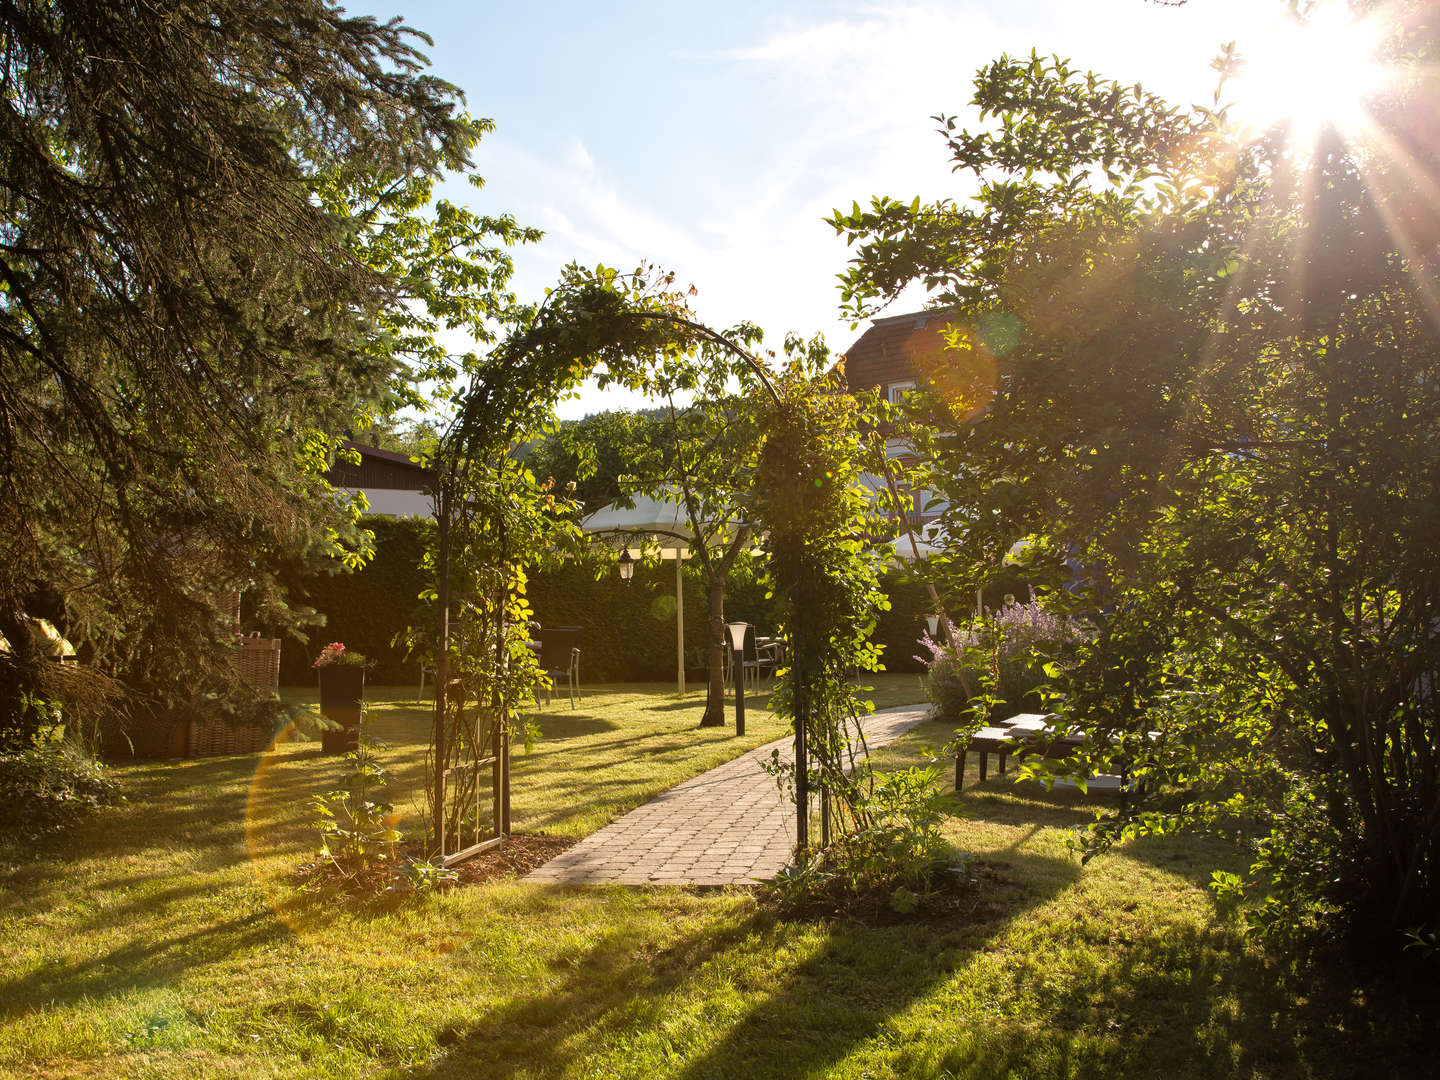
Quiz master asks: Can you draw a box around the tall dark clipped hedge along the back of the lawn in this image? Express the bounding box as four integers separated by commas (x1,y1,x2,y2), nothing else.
281,517,926,685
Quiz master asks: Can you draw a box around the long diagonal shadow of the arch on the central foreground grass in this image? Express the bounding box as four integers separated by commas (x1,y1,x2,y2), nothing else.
393,855,1079,1080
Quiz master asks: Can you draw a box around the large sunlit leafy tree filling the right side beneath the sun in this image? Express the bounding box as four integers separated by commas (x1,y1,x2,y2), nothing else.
834,4,1440,943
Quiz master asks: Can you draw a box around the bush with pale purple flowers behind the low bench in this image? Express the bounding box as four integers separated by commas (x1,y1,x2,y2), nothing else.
916,596,1090,719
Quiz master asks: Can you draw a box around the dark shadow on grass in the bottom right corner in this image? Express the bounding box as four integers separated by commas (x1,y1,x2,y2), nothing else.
891,927,1434,1080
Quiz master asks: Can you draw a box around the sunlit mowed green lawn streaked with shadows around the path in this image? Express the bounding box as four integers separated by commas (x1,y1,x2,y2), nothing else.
0,688,1436,1080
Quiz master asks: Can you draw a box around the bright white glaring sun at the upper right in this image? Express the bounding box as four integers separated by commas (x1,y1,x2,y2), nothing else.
1225,0,1388,145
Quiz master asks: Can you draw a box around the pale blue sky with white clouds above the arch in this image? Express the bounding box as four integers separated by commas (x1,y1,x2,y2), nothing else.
368,0,1282,416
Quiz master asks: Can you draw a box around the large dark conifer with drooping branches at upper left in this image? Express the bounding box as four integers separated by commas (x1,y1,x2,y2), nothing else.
0,0,489,722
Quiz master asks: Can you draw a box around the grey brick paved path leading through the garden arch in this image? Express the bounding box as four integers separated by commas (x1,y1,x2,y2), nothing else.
526,706,927,886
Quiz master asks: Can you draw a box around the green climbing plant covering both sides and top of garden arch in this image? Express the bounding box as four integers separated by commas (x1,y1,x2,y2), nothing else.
429,266,904,861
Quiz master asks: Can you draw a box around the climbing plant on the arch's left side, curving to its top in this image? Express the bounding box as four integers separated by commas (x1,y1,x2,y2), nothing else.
426,268,694,861
